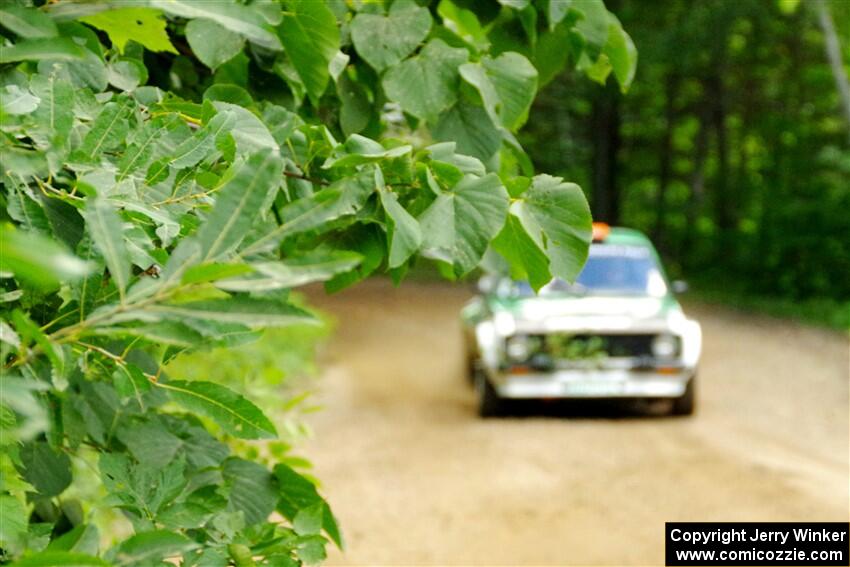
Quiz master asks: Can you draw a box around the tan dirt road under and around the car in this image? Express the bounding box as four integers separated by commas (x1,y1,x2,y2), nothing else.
302,281,850,565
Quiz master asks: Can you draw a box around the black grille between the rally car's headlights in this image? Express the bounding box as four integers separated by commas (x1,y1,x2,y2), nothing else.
539,333,655,360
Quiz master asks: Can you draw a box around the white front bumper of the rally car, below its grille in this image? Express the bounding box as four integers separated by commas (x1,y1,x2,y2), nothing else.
491,369,695,398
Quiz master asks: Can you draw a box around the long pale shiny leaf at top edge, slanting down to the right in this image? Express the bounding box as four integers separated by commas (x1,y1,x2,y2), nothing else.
150,0,281,51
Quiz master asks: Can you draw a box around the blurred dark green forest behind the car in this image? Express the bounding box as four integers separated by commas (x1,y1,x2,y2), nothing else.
521,0,850,321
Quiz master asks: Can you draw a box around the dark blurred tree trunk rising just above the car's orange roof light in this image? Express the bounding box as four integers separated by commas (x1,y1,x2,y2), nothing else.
591,81,620,224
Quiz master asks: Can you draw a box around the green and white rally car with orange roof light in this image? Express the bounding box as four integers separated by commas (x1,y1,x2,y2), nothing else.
462,223,702,416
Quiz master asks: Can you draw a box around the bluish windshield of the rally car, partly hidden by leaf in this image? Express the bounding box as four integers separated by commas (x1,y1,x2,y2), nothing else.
506,244,667,297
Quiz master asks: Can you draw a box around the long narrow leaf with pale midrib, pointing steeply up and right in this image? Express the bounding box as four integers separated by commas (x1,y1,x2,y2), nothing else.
198,151,283,262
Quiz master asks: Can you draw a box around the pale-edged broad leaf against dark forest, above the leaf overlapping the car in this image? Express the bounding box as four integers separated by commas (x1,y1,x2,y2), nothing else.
460,52,537,131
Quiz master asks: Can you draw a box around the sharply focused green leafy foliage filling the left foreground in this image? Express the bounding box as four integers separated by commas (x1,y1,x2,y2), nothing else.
0,0,635,565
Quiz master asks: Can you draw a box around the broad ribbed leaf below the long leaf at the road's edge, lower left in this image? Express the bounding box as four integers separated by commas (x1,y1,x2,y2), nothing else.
221,458,278,525
